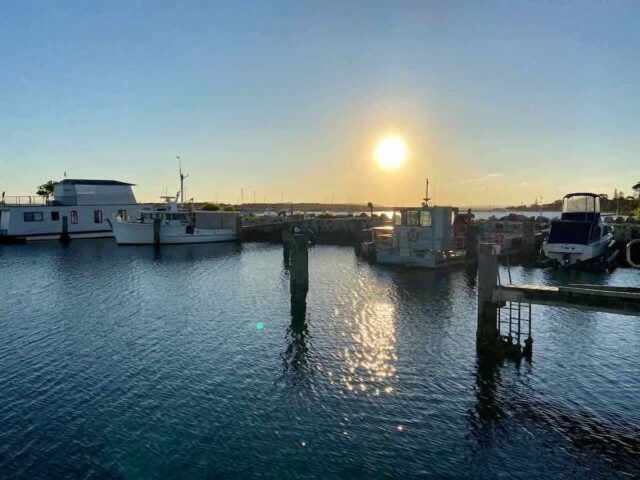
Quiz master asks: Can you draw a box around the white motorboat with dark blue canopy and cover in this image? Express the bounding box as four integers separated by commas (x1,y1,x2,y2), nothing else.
542,193,613,267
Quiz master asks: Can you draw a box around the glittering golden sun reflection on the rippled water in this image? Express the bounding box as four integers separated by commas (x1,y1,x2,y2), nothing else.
341,302,397,396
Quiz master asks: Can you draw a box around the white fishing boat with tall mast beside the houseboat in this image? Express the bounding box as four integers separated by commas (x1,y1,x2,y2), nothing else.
110,169,238,245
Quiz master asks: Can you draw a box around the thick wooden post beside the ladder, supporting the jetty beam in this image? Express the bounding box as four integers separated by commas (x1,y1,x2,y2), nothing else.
476,243,500,350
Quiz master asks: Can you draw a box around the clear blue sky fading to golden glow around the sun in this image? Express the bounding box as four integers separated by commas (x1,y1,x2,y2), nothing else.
0,0,640,206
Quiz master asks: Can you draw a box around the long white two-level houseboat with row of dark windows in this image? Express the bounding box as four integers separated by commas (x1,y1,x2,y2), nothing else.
0,179,141,243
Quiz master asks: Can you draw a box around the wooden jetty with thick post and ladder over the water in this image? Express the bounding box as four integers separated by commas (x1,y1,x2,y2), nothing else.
476,244,640,359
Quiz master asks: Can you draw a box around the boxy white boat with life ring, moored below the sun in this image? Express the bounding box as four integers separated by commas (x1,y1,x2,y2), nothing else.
375,206,467,268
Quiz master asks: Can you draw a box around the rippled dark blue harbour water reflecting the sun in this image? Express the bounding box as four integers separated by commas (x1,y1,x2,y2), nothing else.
0,240,640,478
